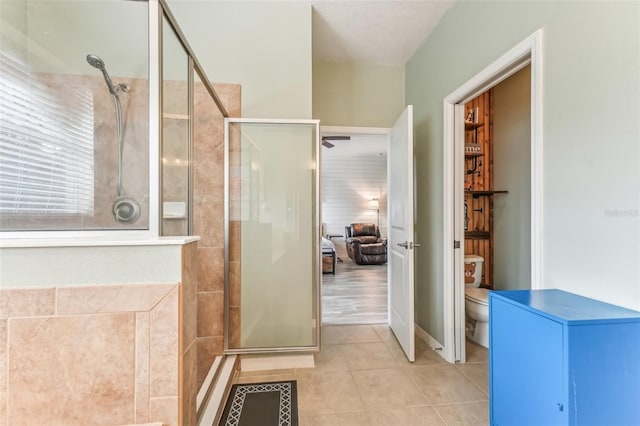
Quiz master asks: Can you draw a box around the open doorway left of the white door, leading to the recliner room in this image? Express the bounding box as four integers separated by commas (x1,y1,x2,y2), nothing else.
320,126,389,325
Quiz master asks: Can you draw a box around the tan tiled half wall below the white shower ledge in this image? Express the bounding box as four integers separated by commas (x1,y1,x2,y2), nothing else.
0,243,198,426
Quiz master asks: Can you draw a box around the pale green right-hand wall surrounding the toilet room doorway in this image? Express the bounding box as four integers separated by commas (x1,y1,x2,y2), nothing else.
405,1,640,342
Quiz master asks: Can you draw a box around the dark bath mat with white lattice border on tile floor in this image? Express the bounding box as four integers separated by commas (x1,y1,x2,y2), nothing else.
220,380,298,426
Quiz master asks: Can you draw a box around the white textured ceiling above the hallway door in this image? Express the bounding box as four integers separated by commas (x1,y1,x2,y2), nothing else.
309,0,455,65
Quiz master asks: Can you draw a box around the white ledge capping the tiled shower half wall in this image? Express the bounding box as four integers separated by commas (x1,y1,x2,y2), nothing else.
0,236,200,248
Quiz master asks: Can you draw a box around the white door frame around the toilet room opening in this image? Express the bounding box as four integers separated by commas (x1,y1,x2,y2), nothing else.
442,29,543,363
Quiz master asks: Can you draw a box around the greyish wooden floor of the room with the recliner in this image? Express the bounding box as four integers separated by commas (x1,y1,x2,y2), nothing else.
322,239,387,324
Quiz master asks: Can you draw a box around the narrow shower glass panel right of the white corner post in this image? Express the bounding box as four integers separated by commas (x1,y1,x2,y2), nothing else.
161,17,190,236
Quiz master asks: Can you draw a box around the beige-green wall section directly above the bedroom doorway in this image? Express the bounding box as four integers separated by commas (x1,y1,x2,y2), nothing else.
313,60,404,127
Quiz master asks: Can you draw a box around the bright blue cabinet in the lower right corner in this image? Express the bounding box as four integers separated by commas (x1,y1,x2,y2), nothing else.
489,290,640,426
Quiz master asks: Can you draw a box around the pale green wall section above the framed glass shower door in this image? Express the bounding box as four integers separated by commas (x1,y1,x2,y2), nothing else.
169,0,312,118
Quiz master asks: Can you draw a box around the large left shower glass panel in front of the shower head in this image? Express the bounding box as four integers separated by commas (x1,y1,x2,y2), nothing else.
0,0,149,231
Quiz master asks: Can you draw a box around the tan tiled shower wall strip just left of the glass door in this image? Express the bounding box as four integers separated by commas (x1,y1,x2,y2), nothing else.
193,83,241,384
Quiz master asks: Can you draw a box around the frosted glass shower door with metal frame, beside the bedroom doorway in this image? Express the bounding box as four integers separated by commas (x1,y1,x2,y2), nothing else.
225,119,320,353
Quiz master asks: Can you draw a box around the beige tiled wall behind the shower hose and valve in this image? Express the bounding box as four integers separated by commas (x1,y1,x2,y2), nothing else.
0,74,149,230
